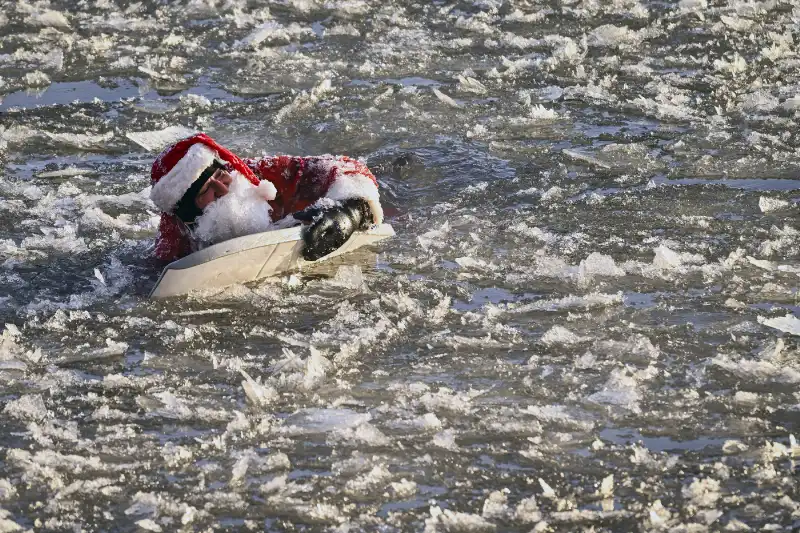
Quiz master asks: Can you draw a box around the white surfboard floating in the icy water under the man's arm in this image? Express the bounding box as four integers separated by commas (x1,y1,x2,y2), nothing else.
150,224,394,298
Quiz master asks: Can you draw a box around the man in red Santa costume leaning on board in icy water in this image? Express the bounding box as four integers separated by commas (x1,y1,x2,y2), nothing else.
150,133,383,261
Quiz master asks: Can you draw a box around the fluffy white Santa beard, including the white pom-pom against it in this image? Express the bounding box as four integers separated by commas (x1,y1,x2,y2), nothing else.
193,172,277,246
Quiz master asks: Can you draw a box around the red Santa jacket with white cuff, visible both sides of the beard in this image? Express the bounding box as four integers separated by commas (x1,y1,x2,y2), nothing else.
154,155,383,261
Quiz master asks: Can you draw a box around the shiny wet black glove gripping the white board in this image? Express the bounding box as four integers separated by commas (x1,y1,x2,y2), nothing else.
293,198,372,261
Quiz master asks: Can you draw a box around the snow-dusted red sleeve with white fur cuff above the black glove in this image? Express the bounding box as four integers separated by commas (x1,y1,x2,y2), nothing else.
245,155,383,224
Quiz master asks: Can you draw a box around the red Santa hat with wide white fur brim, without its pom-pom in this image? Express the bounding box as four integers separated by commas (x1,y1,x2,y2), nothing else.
150,133,259,213
